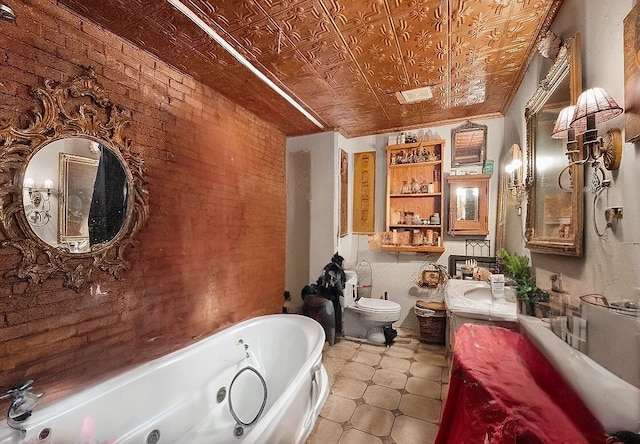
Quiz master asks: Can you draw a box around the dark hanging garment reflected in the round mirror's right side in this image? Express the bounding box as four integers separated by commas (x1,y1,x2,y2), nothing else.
89,145,128,245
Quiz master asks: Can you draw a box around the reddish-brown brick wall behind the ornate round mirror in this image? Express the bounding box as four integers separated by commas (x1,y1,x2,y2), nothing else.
0,0,285,400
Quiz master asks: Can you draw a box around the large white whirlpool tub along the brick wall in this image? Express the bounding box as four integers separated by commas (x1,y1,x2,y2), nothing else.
0,314,329,444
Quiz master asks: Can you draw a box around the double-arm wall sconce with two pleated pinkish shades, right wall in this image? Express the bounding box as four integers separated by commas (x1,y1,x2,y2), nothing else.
551,87,622,190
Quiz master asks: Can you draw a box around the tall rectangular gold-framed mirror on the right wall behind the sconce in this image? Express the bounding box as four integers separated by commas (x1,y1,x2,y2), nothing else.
525,34,584,256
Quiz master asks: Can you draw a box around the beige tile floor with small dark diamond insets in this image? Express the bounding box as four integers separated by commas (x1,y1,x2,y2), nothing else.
306,329,449,444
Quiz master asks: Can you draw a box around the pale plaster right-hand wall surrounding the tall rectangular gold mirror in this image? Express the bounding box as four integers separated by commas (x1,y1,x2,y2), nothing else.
505,0,640,301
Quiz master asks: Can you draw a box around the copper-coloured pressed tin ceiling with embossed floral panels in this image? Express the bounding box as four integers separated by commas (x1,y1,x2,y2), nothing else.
59,0,562,137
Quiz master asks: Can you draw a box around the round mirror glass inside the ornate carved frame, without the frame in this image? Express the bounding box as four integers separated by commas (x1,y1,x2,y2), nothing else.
22,137,129,253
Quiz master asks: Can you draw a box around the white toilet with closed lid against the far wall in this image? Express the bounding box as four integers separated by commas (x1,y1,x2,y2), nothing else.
340,270,400,344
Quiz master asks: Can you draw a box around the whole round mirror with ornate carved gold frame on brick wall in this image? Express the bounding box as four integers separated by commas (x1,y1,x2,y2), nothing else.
0,68,149,290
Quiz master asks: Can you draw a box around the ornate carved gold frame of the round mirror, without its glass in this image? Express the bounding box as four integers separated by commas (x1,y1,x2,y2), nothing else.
0,68,149,291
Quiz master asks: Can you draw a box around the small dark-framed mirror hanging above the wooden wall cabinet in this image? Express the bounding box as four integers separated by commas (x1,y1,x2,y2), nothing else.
451,122,487,168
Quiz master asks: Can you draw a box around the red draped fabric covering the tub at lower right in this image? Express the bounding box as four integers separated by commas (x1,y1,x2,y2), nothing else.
435,324,606,444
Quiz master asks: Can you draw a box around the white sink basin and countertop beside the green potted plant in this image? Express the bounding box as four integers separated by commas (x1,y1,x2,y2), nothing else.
445,279,518,322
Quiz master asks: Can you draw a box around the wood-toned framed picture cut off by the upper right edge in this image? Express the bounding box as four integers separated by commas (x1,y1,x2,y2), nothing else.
624,3,640,142
